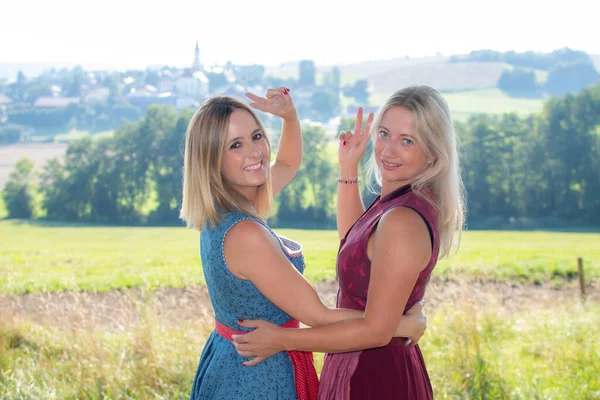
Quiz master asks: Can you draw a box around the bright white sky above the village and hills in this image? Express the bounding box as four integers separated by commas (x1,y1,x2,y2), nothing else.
0,0,600,69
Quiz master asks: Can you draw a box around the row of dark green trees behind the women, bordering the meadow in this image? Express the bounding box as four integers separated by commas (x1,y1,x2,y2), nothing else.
3,84,600,228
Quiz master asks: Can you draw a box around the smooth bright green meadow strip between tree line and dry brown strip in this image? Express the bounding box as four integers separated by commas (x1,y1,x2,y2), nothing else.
0,220,600,294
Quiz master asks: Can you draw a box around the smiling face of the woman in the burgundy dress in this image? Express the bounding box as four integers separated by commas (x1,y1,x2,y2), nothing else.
374,107,428,194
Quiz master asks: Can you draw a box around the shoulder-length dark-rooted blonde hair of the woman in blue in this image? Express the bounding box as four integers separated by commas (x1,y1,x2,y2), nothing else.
179,96,273,230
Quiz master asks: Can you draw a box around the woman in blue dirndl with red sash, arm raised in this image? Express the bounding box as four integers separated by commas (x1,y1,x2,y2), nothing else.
181,88,425,400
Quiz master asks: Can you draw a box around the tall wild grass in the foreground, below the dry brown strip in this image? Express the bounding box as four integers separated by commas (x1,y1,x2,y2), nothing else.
0,294,600,399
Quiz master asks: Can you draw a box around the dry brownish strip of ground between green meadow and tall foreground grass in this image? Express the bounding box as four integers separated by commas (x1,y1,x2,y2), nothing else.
0,278,600,329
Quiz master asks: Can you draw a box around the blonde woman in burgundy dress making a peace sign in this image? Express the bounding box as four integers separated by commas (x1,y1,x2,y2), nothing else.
235,86,463,400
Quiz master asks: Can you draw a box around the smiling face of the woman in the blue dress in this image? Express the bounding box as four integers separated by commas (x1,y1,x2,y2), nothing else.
221,109,271,201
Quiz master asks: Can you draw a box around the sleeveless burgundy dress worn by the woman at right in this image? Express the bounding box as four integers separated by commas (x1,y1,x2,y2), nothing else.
318,186,439,400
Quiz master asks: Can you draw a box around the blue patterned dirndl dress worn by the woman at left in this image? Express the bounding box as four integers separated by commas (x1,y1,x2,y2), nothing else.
190,213,304,400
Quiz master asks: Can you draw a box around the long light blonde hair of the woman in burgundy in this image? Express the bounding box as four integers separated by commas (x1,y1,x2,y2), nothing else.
369,86,465,258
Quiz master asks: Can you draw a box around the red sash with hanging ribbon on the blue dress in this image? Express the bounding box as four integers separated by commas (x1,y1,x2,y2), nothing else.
216,319,319,400
